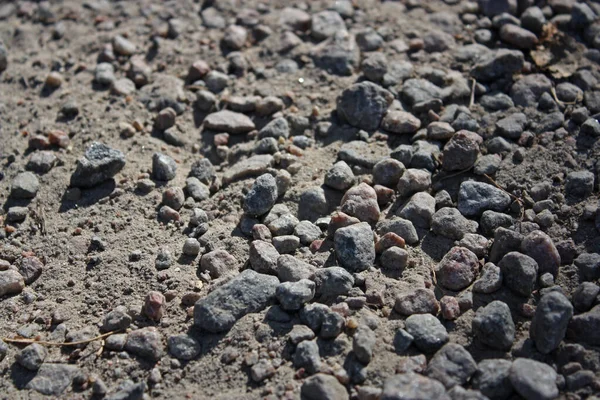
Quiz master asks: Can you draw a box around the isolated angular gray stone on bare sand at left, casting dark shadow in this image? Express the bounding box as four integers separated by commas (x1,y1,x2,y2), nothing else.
71,142,125,188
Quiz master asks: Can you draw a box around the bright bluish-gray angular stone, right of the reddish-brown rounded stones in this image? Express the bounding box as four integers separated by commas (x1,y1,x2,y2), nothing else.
458,181,511,216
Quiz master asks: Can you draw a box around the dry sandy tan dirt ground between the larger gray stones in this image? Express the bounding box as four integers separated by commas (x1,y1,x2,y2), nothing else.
0,0,600,399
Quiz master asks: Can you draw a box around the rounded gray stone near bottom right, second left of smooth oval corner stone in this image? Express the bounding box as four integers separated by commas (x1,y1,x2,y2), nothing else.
427,343,477,389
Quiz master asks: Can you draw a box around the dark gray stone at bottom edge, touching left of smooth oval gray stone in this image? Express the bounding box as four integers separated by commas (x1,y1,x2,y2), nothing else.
472,359,514,400
